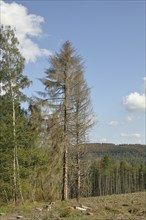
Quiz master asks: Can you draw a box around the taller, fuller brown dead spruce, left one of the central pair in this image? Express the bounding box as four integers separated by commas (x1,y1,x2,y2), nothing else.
39,41,93,200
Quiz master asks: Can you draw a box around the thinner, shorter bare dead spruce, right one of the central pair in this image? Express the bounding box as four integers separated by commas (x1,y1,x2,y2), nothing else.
72,69,95,200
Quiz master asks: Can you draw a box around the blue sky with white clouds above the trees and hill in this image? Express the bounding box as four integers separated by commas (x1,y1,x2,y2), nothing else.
1,0,146,144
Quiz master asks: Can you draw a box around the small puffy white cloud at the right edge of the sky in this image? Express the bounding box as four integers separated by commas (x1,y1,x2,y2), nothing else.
122,92,146,111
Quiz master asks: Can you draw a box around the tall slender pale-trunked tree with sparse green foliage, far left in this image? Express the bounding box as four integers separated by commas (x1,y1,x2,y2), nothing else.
0,26,30,203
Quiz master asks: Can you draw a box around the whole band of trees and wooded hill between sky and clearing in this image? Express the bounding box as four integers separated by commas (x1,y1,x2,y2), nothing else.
0,26,146,205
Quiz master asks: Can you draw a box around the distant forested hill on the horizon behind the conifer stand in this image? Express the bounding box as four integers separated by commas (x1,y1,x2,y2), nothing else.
82,143,146,164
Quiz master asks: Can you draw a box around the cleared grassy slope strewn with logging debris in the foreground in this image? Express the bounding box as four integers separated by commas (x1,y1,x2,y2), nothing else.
0,192,146,220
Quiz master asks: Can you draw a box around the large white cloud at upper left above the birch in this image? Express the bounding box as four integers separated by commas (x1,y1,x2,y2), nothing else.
0,1,51,62
